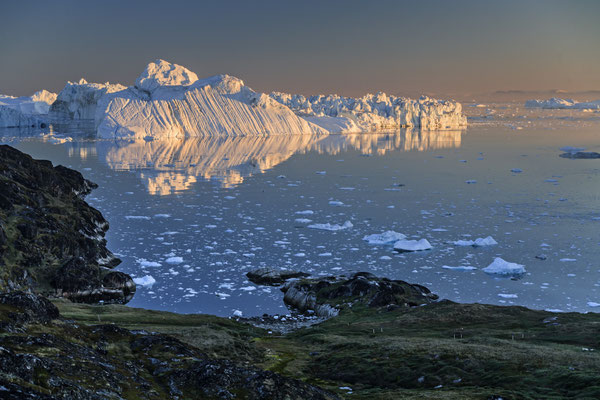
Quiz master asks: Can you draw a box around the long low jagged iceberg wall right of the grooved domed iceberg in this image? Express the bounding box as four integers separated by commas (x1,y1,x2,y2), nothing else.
271,92,467,133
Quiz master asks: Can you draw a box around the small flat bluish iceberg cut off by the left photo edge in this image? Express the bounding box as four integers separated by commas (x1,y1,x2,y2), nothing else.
0,90,56,128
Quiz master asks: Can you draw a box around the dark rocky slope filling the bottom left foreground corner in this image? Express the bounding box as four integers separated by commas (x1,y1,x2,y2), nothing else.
0,293,339,400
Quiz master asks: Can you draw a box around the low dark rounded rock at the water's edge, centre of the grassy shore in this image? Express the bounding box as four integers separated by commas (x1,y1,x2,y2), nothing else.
281,272,438,317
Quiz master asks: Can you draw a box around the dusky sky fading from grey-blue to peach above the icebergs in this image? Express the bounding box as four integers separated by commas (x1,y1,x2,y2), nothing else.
0,0,600,96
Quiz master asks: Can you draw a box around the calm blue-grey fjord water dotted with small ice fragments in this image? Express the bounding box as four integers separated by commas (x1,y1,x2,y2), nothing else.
0,115,600,316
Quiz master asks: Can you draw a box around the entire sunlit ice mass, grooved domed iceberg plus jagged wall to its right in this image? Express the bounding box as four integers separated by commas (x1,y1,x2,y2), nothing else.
45,60,466,139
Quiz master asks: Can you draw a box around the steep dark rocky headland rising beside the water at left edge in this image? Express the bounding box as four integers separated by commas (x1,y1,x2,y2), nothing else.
0,146,135,303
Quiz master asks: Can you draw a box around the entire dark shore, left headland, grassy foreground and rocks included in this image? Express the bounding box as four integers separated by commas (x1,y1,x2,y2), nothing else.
0,146,600,400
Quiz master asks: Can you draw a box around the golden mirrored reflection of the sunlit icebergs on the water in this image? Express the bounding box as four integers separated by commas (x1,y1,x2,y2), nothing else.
92,129,462,195
